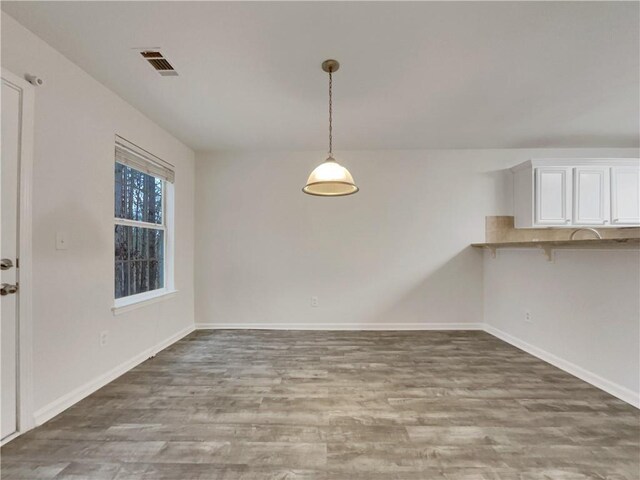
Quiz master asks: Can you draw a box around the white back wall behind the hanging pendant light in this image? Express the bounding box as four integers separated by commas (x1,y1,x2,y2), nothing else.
196,149,638,334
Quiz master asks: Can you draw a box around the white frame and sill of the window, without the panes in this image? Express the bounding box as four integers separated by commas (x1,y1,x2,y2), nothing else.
111,137,178,315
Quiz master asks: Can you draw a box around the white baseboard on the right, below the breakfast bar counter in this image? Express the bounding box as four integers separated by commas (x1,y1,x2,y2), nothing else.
484,324,640,408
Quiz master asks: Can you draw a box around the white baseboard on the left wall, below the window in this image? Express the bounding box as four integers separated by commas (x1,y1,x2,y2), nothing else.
33,325,195,426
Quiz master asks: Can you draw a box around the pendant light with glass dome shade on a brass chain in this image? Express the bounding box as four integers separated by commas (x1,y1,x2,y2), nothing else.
302,60,358,197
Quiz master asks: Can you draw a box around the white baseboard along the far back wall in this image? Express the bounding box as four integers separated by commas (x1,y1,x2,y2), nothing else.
196,323,484,331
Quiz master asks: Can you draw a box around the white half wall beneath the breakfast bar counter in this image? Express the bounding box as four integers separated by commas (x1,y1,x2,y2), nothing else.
484,249,640,404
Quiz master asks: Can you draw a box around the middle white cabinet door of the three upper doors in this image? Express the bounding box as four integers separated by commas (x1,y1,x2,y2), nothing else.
572,167,609,225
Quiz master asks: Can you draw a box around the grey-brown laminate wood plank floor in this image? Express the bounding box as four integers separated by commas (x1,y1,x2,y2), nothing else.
1,330,640,480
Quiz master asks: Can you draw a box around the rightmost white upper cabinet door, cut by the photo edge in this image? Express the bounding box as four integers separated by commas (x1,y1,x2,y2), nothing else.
611,166,640,225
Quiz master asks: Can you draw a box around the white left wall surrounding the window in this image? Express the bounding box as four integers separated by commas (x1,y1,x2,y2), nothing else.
2,13,194,418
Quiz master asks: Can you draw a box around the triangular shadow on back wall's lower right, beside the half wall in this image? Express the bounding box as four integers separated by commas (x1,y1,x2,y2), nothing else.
367,247,483,325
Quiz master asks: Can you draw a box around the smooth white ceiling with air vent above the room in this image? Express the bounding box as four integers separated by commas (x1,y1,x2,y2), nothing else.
2,1,640,150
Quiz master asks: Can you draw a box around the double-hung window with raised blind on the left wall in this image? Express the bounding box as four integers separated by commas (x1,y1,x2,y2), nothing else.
114,137,174,307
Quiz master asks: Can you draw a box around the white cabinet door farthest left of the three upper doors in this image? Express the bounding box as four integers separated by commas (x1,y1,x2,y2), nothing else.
535,167,571,225
